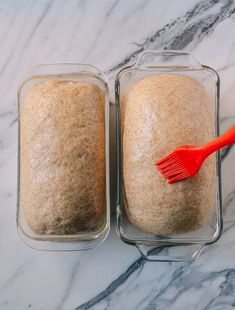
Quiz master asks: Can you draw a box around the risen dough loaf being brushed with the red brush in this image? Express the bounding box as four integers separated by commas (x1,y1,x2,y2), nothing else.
122,74,215,234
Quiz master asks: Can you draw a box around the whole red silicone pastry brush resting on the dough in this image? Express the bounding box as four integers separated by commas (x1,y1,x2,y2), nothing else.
155,125,235,184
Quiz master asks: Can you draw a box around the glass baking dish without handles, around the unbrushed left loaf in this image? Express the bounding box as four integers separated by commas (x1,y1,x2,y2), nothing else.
17,63,110,251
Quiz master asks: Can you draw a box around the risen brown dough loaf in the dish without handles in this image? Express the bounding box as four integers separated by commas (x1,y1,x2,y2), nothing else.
20,80,105,235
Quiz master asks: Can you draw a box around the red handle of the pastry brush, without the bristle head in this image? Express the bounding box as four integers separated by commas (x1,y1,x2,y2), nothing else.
202,125,235,158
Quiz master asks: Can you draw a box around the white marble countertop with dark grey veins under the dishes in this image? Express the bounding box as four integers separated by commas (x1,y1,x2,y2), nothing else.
0,0,235,310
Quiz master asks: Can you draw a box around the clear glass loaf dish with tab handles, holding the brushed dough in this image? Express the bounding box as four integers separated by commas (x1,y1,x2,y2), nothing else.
115,51,222,261
